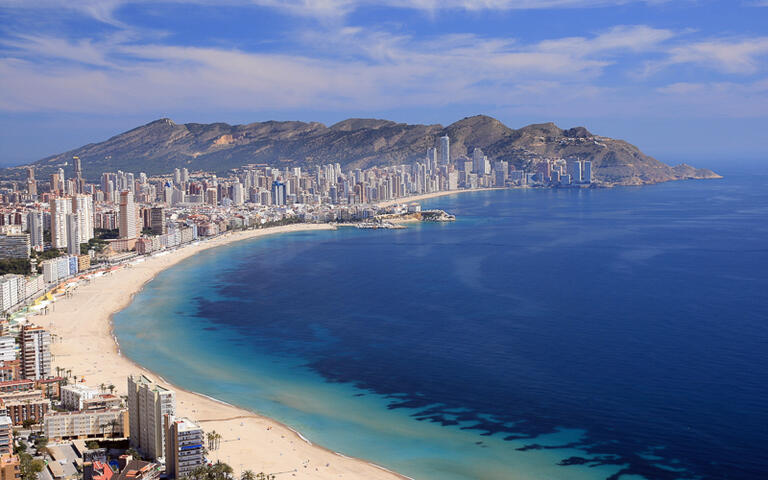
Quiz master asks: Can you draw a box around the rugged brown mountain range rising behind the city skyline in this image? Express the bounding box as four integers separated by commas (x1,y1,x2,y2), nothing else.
0,115,719,185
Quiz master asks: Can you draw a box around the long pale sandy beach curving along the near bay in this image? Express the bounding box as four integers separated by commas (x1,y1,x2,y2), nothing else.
39,224,406,479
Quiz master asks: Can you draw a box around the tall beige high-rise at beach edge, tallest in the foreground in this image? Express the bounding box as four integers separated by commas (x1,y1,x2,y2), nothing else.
128,375,176,459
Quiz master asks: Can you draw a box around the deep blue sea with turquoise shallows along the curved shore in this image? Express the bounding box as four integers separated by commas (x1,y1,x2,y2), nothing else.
115,163,768,480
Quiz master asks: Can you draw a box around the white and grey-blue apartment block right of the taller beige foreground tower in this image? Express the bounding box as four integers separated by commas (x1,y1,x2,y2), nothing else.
165,415,205,480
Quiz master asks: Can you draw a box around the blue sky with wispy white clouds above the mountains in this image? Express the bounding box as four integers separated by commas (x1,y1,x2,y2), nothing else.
0,0,768,165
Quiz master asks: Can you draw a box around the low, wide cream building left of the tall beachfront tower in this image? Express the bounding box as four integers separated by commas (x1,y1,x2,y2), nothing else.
43,408,129,441
